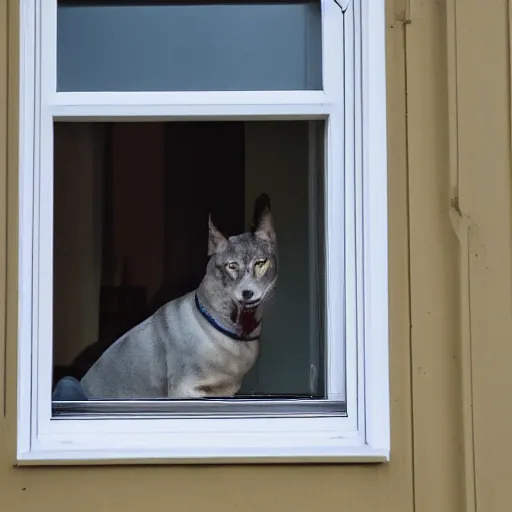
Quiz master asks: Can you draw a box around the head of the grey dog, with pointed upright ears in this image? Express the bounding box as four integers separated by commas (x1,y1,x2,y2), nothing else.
207,194,278,310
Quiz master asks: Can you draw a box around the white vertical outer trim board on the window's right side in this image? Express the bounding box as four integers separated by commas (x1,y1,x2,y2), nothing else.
361,0,390,456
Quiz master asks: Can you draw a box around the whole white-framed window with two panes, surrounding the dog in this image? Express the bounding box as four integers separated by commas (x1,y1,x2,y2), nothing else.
18,0,389,464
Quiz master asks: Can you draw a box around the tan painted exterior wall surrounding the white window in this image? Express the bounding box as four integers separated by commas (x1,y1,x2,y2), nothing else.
0,0,512,512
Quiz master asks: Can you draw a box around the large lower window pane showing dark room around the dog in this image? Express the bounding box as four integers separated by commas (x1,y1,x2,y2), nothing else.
53,121,325,400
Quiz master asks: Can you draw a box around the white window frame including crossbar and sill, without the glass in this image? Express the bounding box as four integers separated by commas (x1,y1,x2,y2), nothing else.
17,0,390,465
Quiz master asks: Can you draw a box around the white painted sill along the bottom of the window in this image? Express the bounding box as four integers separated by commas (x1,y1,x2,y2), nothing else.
17,403,390,466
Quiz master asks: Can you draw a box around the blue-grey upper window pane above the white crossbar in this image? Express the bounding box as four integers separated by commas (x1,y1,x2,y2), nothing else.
57,0,322,91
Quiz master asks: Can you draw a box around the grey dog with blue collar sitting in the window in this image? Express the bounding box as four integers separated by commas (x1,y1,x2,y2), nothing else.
81,194,278,400
